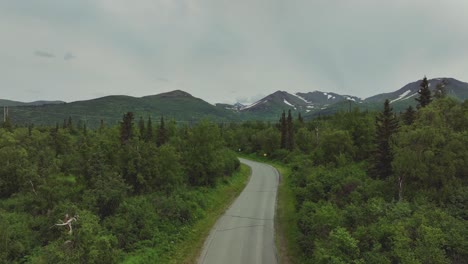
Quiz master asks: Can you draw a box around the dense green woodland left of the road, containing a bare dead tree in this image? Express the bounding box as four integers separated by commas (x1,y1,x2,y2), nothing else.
0,113,239,263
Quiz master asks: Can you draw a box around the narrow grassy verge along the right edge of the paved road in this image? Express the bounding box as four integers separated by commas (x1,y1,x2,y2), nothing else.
241,155,300,264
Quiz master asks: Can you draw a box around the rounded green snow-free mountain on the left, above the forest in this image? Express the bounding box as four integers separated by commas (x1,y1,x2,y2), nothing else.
9,90,237,127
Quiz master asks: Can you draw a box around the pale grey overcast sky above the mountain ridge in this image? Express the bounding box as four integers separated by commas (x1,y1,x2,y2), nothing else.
0,0,468,103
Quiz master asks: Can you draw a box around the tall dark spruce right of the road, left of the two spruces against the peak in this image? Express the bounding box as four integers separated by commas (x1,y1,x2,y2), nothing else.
373,100,398,179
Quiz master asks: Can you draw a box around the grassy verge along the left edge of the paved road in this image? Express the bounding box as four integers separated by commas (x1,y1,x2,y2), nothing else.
123,164,251,264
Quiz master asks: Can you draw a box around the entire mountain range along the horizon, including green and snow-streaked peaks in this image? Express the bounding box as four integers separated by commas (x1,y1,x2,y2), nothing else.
4,78,468,127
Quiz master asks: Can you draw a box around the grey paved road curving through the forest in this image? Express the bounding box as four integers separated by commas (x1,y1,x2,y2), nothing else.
198,159,279,264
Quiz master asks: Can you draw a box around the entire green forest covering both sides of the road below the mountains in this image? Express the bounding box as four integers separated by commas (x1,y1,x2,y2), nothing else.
0,82,468,263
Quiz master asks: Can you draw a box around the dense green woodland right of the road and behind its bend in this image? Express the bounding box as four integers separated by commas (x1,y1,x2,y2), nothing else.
224,84,468,263
